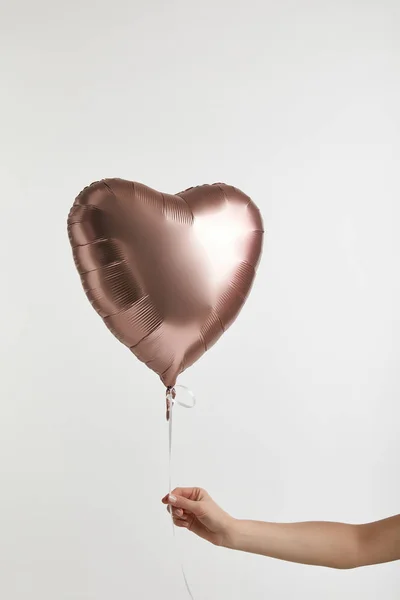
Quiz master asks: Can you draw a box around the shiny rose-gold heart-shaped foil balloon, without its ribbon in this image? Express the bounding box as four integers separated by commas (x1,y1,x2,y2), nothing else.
68,179,263,386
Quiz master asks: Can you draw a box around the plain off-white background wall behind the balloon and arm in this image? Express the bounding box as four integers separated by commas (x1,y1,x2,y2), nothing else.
0,0,400,600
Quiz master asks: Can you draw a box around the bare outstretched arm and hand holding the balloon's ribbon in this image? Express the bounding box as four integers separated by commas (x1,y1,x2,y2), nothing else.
162,488,400,569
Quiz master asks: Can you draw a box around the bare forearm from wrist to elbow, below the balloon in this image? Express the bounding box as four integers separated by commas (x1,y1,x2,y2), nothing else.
226,521,360,569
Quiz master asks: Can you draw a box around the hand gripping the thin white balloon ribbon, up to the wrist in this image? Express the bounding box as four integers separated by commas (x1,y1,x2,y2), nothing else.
162,488,234,546
